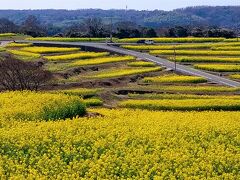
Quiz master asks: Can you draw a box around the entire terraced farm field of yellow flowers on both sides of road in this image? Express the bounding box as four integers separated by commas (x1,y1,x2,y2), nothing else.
0,37,240,179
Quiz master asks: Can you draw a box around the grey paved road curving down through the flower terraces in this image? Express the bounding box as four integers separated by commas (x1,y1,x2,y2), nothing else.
17,41,240,87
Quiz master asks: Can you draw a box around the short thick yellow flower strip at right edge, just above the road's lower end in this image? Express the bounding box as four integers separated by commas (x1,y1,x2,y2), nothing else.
194,64,240,72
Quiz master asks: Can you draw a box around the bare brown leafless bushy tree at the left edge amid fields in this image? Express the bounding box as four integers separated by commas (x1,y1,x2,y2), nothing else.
0,55,52,91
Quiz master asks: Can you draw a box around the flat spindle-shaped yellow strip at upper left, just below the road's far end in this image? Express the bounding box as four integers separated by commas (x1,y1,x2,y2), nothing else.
21,47,80,54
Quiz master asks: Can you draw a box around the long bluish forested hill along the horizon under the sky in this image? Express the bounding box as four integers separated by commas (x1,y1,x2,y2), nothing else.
0,6,240,29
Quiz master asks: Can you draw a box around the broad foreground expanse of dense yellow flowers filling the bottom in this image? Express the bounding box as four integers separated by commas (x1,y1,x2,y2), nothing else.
0,109,240,179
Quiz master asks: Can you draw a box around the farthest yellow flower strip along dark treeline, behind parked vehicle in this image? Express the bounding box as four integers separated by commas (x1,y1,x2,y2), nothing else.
117,37,225,43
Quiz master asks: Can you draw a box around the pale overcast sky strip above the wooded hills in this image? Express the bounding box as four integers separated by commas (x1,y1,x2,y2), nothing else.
0,0,240,10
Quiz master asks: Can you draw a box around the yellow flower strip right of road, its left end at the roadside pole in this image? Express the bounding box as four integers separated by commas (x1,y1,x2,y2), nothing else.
172,56,240,63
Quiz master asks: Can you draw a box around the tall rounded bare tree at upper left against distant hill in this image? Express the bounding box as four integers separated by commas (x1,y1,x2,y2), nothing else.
21,15,46,37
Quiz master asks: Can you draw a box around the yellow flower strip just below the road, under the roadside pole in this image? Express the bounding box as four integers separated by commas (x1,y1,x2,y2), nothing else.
143,74,207,83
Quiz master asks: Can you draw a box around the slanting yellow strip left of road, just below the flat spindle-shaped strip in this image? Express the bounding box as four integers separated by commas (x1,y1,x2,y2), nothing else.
44,52,109,61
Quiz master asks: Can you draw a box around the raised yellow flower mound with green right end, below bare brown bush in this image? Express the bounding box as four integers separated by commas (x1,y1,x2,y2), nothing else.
0,91,85,120
